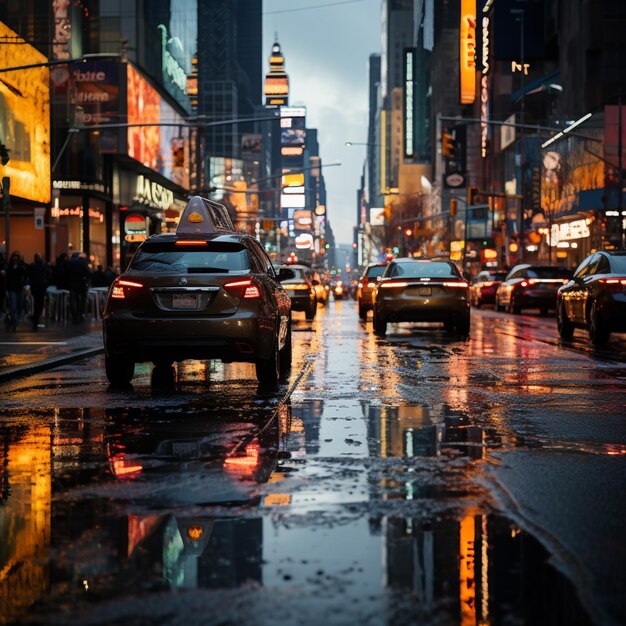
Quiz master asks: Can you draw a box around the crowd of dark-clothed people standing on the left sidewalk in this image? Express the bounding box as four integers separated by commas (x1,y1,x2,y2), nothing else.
0,250,117,332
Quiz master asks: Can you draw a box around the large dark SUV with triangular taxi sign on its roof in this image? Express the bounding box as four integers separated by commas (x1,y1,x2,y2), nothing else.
102,196,291,386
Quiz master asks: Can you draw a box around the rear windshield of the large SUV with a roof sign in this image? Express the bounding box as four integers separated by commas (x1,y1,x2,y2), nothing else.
130,242,250,274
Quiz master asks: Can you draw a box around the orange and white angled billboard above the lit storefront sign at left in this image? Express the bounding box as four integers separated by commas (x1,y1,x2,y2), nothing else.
126,64,189,187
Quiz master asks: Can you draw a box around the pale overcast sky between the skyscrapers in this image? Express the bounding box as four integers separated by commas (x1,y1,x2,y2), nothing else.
263,0,381,243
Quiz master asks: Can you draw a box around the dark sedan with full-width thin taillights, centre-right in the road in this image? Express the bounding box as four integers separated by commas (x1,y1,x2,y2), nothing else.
374,258,470,336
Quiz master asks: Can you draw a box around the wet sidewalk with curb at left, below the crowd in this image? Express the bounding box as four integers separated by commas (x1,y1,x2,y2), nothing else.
0,319,104,383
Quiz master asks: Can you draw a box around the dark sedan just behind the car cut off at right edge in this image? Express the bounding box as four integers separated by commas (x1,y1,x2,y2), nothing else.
496,263,572,315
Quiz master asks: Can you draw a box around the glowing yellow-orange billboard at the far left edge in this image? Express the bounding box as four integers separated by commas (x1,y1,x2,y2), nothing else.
0,23,50,202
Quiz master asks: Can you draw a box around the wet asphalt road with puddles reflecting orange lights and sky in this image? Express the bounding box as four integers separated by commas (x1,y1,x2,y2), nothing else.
0,302,626,625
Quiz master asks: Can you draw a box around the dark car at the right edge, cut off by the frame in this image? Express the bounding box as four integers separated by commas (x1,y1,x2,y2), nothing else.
557,250,626,345
